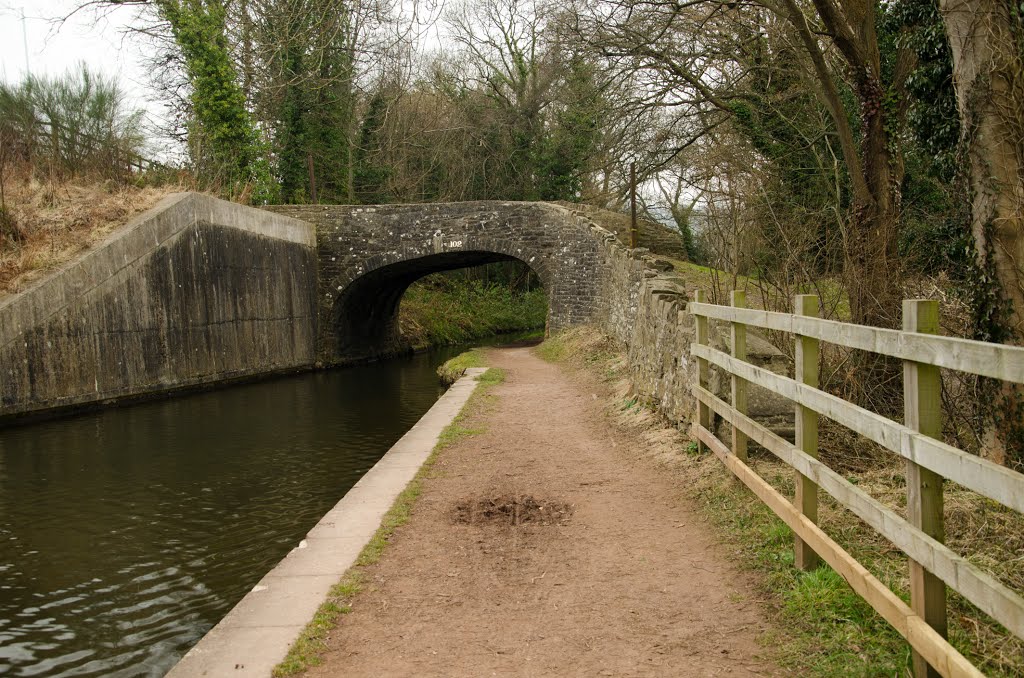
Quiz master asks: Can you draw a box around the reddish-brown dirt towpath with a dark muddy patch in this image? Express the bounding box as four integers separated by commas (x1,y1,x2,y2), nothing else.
310,348,778,676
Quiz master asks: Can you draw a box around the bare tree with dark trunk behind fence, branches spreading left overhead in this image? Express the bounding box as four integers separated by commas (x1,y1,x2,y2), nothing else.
580,0,912,326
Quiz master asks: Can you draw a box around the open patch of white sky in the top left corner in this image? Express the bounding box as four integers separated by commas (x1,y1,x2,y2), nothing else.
0,0,172,152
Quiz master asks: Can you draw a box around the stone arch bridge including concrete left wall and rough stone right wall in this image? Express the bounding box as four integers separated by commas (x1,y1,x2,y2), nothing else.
0,194,792,446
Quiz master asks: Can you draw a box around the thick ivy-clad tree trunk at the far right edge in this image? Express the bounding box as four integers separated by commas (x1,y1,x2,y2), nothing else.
939,0,1024,464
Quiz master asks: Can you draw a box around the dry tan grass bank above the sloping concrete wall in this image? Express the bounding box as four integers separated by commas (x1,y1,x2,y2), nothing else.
0,168,184,297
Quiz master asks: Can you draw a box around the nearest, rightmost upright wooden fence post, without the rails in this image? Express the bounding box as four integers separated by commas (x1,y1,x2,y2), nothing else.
903,299,946,678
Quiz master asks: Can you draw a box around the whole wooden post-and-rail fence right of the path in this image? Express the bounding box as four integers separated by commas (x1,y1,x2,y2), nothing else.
689,291,1024,676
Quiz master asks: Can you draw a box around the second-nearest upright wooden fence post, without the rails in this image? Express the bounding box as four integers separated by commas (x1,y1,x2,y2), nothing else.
793,294,818,570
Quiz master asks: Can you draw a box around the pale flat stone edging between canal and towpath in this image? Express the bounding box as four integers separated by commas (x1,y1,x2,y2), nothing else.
167,368,485,678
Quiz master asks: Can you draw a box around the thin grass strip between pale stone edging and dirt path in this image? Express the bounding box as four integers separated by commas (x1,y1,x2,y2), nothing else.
273,366,505,678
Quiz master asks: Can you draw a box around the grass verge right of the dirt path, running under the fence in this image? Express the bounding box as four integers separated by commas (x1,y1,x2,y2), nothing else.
537,329,1024,677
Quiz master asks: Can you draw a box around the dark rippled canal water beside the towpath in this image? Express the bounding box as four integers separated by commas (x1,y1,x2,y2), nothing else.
0,348,462,676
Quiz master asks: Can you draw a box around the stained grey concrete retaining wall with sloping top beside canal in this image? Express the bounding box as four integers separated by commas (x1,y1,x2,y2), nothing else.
0,194,316,419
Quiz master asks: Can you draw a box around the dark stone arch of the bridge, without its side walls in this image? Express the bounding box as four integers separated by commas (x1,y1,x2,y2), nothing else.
269,202,610,365
